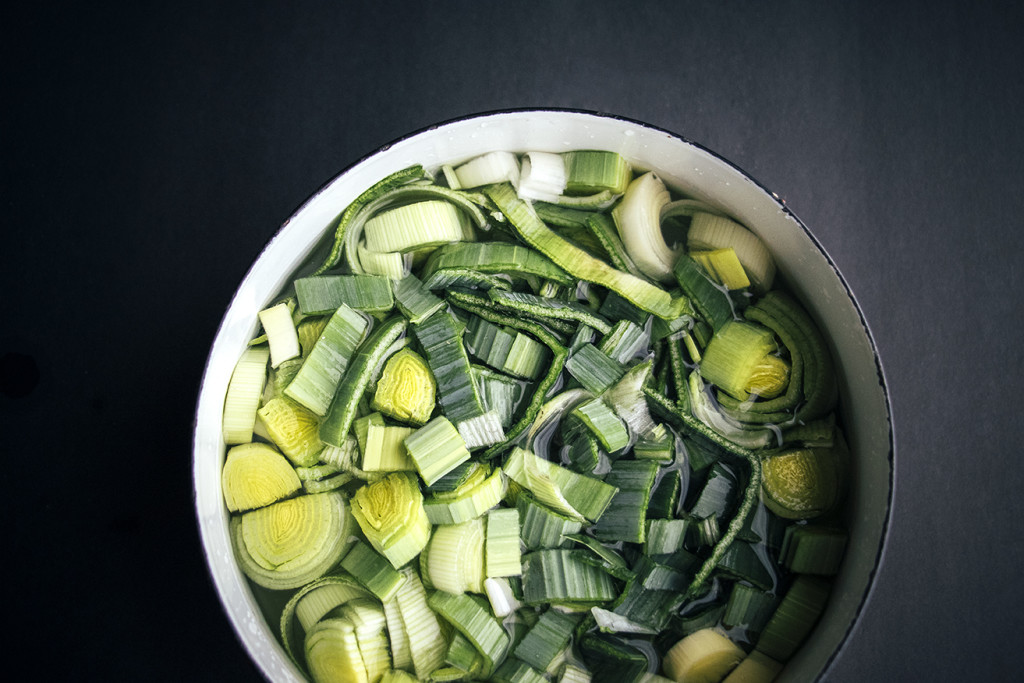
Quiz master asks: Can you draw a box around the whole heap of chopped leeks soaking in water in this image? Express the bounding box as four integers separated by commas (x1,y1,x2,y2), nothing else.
222,151,847,683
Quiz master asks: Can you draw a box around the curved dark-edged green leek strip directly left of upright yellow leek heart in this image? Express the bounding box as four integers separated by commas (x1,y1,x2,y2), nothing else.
319,315,409,447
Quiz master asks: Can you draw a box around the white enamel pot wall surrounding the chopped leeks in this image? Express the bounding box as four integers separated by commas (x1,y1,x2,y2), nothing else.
194,110,894,682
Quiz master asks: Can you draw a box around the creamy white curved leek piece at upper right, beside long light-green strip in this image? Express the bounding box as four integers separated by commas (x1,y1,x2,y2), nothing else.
611,172,678,282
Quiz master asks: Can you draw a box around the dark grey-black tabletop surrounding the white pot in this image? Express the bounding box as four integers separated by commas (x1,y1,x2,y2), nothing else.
0,2,1024,682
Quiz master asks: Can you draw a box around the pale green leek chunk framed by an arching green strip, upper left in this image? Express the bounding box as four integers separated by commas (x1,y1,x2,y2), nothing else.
362,200,464,252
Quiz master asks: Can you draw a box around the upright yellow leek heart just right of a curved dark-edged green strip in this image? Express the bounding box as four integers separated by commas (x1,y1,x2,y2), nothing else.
371,348,437,426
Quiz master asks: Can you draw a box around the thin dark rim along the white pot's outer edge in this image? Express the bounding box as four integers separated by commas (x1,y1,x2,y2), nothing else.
190,106,896,680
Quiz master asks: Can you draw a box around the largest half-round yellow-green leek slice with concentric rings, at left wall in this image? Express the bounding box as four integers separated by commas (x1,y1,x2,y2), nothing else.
229,492,351,590
